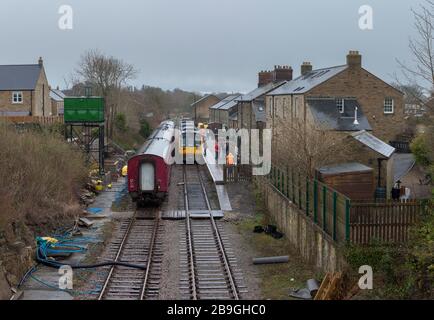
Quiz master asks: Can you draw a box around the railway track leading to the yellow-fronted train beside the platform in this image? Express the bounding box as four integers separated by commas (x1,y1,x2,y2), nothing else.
181,166,245,300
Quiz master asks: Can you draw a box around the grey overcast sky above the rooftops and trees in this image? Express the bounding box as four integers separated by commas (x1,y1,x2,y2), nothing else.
0,0,422,92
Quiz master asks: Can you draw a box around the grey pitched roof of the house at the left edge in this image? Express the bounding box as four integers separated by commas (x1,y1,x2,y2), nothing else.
0,64,42,91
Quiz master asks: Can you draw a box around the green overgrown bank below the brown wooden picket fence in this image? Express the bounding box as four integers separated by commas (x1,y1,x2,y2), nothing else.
346,202,434,299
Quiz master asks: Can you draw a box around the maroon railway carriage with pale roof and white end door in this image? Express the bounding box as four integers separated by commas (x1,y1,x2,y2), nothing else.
128,121,175,203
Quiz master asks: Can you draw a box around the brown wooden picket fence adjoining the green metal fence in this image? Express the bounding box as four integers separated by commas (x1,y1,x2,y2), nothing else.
350,200,427,244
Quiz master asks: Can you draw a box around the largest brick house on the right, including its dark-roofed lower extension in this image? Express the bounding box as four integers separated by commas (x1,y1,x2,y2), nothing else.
265,51,405,198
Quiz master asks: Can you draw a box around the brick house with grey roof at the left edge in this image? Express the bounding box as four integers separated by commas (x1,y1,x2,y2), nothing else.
0,58,52,116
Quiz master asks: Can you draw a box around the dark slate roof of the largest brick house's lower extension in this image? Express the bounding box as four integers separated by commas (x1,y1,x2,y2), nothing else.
306,98,372,131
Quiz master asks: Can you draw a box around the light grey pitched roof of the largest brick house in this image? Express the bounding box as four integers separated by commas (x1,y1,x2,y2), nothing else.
268,65,348,96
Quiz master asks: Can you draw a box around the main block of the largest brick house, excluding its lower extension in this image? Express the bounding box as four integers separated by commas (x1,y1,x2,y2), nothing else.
266,51,405,142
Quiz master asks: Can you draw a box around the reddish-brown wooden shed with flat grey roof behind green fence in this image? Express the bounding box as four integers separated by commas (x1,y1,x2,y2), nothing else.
316,162,375,200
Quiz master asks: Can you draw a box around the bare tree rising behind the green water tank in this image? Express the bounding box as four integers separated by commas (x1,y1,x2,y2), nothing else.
74,50,137,138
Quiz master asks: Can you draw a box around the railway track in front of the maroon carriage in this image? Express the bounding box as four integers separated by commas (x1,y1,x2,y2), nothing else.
98,211,163,300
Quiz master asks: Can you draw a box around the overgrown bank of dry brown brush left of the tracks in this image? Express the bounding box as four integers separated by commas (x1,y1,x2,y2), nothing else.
0,122,87,299
